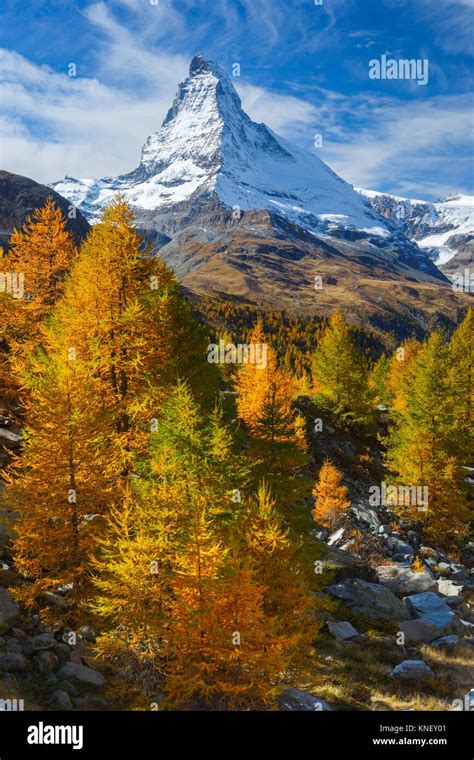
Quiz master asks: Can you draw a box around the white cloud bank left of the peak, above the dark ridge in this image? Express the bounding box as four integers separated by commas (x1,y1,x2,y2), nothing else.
0,50,179,182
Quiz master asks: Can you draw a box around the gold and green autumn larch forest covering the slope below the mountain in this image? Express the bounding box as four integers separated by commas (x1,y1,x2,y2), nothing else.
0,196,474,710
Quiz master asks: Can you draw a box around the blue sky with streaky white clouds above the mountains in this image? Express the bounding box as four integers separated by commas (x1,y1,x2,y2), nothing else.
0,0,474,198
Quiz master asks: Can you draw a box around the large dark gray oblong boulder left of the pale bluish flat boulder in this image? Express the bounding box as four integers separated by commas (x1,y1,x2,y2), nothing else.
328,578,411,621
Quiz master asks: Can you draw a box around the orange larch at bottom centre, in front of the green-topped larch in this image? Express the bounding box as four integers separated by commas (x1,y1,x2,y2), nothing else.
166,524,288,710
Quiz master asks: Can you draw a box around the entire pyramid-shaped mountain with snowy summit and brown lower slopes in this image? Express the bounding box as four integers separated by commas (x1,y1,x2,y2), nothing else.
52,55,472,333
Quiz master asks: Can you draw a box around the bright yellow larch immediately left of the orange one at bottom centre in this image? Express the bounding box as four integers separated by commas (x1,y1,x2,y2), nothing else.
89,480,180,694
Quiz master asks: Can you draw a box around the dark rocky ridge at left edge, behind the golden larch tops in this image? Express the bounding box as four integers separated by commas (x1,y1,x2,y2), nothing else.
0,171,90,247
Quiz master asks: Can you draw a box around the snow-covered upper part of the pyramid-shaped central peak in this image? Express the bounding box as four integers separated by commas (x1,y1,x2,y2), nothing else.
52,55,390,238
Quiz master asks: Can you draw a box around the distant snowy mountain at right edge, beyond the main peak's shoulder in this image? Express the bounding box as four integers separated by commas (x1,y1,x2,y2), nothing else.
356,188,474,271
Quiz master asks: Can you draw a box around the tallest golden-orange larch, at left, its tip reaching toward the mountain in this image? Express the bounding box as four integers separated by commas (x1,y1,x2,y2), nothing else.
3,198,214,616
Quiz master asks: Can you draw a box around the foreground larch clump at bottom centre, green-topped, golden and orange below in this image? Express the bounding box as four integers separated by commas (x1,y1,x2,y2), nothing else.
92,383,286,709
